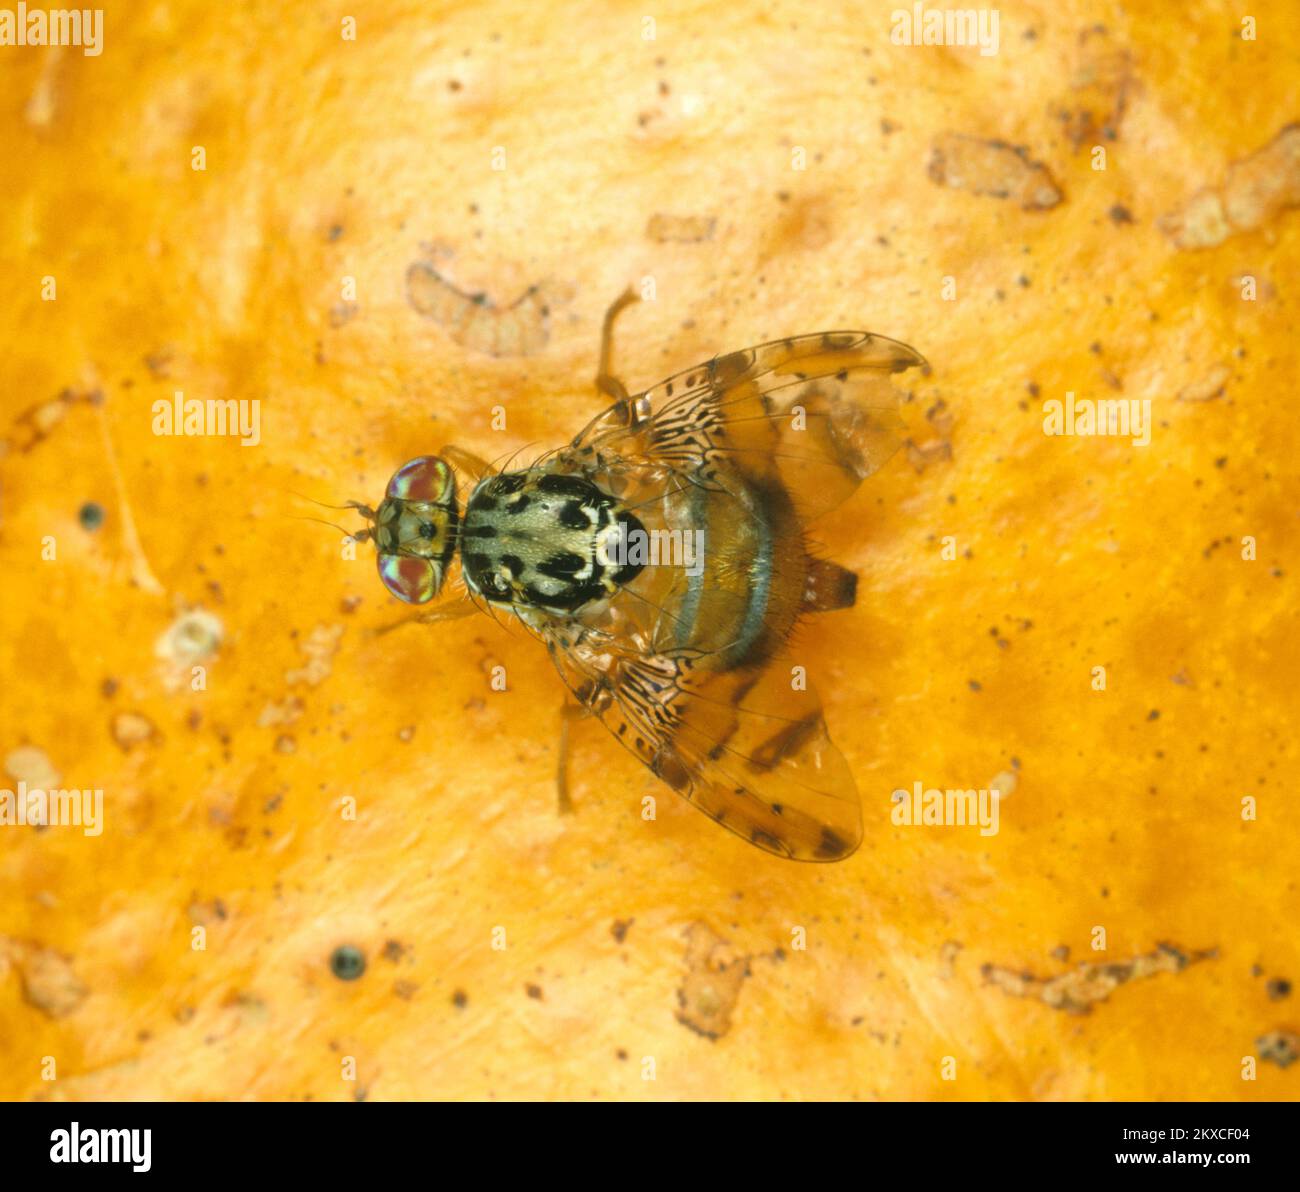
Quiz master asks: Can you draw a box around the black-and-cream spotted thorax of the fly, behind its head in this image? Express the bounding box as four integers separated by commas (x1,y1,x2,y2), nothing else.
460,472,645,612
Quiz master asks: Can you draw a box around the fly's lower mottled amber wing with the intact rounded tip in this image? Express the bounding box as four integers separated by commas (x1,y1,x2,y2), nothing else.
540,621,862,861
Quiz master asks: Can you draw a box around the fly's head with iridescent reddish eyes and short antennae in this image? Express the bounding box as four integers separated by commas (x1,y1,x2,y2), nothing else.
352,455,460,604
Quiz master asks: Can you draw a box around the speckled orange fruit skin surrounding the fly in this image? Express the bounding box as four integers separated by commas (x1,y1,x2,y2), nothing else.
0,0,1300,1100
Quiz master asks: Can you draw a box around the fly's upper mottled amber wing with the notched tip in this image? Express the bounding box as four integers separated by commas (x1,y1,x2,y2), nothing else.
564,331,926,517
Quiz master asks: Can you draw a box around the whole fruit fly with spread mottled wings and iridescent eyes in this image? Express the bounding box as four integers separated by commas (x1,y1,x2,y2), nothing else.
352,292,926,862
